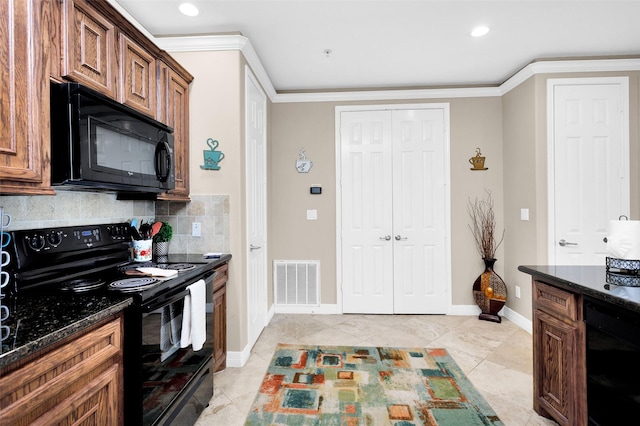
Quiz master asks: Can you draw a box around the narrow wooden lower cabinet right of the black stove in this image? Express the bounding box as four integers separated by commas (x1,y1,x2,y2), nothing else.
213,263,229,371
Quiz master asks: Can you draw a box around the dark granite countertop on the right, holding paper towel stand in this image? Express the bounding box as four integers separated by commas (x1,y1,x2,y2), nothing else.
518,265,640,312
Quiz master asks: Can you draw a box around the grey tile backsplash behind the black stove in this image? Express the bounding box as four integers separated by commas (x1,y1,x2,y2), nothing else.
0,194,230,253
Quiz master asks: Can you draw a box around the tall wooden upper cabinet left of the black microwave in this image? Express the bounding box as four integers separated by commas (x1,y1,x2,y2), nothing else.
0,0,54,195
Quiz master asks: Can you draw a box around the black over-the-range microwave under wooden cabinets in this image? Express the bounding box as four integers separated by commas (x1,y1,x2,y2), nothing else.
51,82,175,198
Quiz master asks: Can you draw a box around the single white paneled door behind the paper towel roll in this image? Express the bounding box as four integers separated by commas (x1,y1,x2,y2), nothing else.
548,78,630,265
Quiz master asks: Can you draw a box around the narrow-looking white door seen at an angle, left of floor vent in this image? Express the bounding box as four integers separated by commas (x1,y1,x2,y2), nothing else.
245,68,267,347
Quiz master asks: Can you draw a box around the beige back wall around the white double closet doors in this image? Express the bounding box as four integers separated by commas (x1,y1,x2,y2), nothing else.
269,97,503,305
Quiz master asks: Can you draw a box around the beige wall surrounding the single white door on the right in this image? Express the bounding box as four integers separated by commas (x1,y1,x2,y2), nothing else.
502,72,640,319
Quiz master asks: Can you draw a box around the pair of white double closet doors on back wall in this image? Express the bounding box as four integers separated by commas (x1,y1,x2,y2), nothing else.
336,104,451,314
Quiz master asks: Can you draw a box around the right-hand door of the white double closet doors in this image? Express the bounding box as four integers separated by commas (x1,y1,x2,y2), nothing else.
392,109,448,314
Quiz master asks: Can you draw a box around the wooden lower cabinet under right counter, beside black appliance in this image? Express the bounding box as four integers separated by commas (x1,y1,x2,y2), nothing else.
533,281,587,426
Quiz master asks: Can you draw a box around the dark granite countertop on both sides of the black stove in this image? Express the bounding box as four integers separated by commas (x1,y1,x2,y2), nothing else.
0,254,231,369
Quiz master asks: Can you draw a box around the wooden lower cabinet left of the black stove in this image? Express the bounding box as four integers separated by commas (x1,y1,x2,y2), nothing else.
0,316,123,426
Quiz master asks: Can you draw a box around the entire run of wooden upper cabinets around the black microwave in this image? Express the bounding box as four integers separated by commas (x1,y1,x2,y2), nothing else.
0,0,193,196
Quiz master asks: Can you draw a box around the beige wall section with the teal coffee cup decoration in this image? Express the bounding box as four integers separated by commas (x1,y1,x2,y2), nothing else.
172,51,247,352
